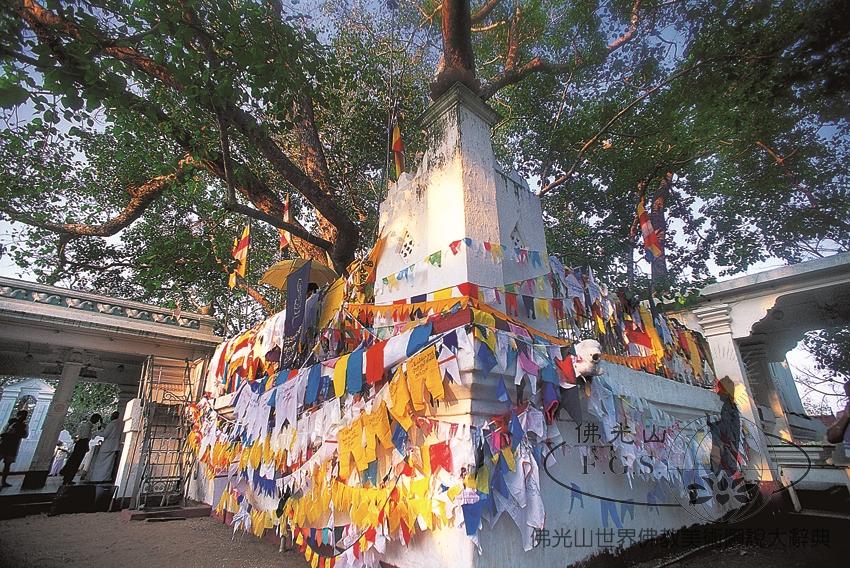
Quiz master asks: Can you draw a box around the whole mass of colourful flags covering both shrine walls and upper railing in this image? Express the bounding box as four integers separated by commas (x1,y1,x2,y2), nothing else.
195,223,724,567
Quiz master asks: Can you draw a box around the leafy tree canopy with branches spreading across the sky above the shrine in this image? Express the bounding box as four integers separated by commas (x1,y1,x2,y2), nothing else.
0,0,850,338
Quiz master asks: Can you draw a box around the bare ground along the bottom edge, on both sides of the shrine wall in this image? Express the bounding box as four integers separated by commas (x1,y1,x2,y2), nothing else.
0,513,850,568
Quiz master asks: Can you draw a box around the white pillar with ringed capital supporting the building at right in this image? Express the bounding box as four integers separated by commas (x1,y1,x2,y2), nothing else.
693,304,777,481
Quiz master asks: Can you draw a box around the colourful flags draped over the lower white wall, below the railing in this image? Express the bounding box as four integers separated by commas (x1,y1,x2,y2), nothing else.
189,288,746,567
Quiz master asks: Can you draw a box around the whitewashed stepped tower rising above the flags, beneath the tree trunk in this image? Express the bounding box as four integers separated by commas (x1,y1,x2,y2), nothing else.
375,84,557,334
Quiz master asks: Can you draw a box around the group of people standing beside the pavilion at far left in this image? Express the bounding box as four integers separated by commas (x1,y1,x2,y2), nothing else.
0,410,123,487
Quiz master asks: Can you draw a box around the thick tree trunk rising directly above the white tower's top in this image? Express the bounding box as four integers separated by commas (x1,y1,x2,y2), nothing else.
431,0,481,100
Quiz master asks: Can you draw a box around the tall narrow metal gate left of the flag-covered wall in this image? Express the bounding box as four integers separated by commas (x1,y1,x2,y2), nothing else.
131,356,203,509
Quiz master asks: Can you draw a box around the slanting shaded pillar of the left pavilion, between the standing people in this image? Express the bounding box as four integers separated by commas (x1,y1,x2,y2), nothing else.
22,351,83,489
